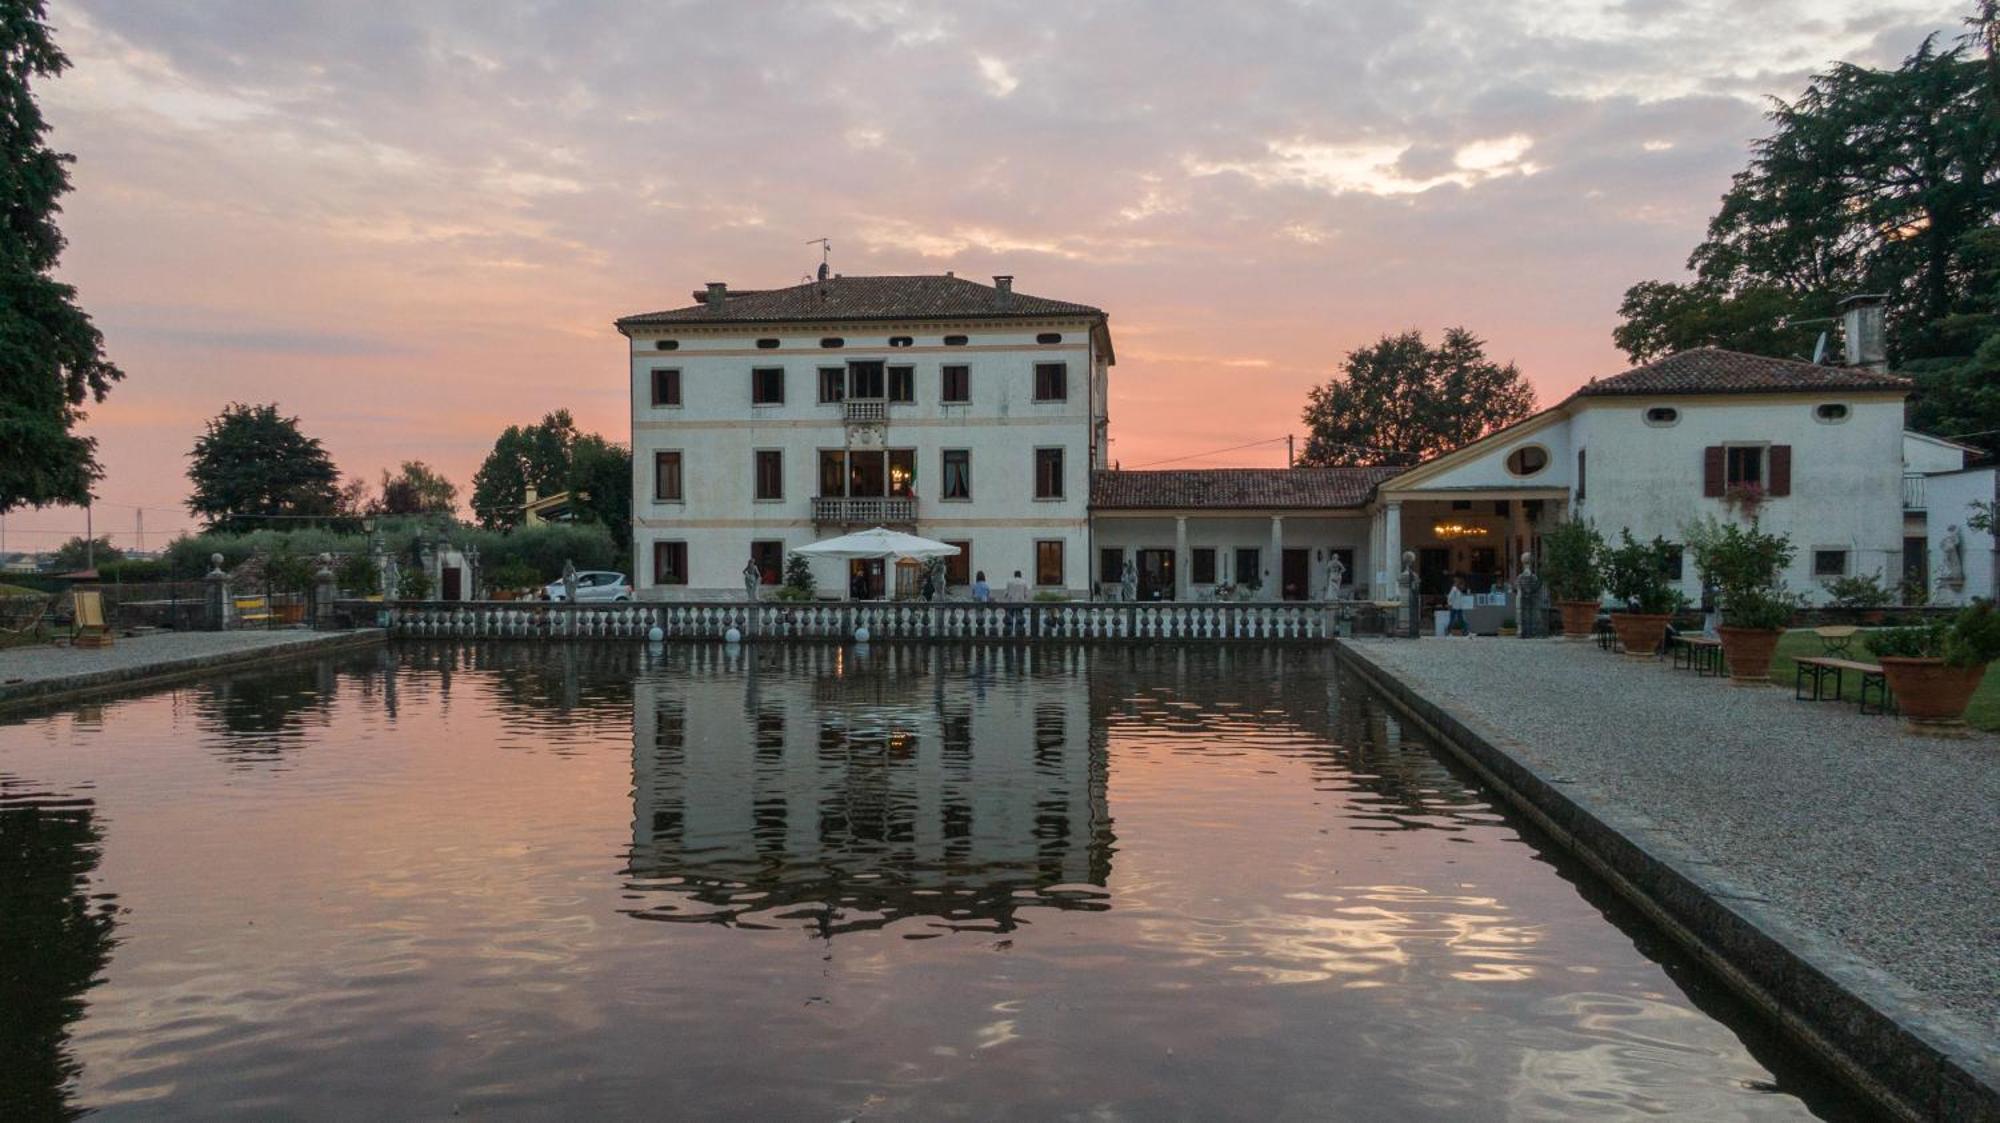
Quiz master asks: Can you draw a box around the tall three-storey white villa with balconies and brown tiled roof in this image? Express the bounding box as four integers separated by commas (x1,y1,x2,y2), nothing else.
618,274,1116,599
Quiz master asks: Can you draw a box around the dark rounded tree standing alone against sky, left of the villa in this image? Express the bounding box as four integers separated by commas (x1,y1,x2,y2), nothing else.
188,402,340,530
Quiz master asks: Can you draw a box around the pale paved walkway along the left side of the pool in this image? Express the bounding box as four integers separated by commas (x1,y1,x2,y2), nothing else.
0,627,380,705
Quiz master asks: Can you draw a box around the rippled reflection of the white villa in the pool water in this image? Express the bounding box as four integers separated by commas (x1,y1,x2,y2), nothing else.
630,647,1112,933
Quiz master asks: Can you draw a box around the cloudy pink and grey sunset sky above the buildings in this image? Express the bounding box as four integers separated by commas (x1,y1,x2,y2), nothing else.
8,0,1968,548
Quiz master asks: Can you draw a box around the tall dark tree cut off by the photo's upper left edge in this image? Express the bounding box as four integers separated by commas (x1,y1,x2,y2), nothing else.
0,0,124,514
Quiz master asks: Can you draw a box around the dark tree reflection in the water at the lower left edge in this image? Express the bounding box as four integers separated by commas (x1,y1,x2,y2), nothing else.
0,773,116,1119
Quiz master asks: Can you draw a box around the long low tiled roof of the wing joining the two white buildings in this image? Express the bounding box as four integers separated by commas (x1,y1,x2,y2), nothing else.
1090,468,1408,510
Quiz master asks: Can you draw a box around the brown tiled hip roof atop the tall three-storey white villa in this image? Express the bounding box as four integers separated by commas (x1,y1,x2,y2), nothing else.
618,276,1104,330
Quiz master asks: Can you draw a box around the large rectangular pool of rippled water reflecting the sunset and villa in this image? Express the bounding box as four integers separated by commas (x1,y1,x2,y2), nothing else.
0,643,1860,1119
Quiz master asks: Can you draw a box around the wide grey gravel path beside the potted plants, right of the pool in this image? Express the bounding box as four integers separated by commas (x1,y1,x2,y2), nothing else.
1352,639,2000,1045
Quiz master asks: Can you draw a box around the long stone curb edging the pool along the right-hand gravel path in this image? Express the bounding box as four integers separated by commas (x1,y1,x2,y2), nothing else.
1334,641,2000,1123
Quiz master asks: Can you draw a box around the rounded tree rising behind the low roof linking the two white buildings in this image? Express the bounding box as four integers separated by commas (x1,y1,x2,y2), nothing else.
1300,328,1534,468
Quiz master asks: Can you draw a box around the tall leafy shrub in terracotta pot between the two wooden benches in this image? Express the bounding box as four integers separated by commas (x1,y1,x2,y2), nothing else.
1686,520,1798,685
